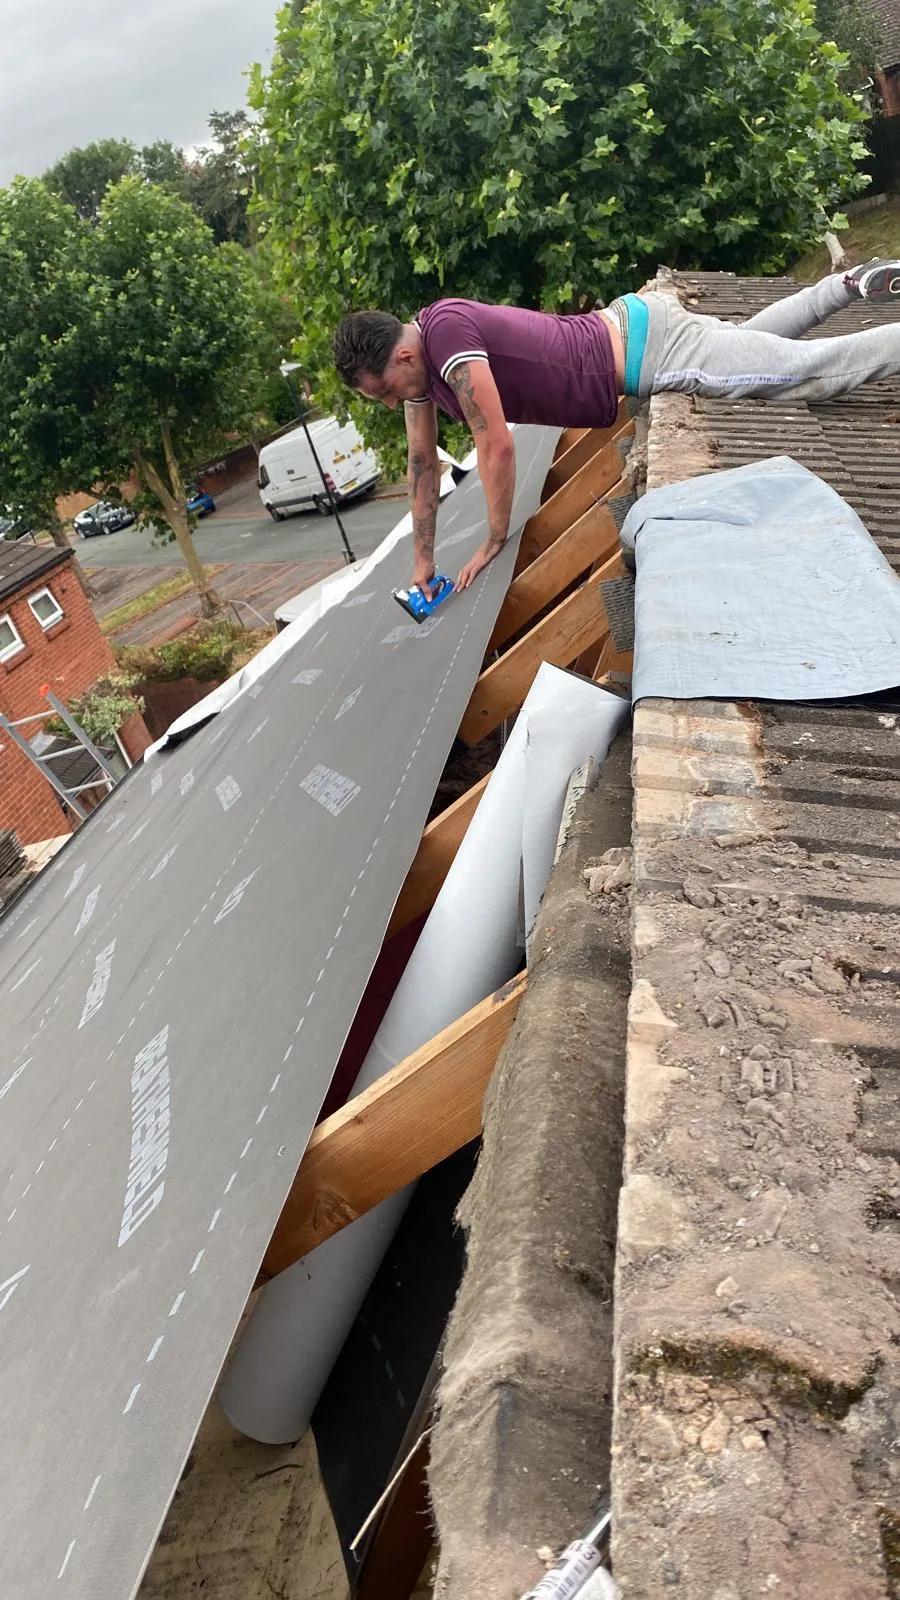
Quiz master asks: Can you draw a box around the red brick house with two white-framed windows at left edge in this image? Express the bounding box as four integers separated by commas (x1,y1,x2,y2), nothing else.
0,539,151,845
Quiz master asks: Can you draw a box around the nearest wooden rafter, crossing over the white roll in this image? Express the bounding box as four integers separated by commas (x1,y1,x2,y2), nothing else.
263,974,525,1277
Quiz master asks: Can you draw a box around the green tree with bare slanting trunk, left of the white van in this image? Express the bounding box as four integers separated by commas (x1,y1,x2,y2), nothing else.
0,178,259,614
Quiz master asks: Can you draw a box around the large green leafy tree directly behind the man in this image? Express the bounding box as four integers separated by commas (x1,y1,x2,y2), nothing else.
250,0,863,467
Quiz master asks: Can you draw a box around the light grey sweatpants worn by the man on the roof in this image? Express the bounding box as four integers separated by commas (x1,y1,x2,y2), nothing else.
639,274,900,400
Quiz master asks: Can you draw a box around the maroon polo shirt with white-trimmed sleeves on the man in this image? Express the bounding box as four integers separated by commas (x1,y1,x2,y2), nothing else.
413,299,618,427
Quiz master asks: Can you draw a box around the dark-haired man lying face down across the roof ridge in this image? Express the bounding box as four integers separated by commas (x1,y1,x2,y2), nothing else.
335,261,900,598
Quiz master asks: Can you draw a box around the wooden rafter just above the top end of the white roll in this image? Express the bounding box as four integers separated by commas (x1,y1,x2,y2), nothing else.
460,552,625,746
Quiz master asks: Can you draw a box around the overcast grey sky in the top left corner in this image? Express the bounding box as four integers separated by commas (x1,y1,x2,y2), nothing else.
0,0,277,184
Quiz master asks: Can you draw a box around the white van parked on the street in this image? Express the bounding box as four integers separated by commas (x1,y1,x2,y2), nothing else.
256,416,378,522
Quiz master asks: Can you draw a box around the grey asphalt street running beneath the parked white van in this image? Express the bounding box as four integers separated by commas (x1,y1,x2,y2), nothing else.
74,490,407,568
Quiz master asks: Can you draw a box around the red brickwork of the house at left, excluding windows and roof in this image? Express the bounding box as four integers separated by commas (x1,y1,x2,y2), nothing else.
0,562,149,845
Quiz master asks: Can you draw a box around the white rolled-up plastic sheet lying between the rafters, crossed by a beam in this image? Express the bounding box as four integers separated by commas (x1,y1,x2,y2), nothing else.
219,662,628,1443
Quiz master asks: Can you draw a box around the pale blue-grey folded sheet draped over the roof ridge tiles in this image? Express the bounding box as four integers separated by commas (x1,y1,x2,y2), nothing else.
621,456,900,701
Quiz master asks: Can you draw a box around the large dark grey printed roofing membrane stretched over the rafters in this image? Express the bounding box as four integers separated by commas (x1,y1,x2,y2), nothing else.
0,427,557,1600
